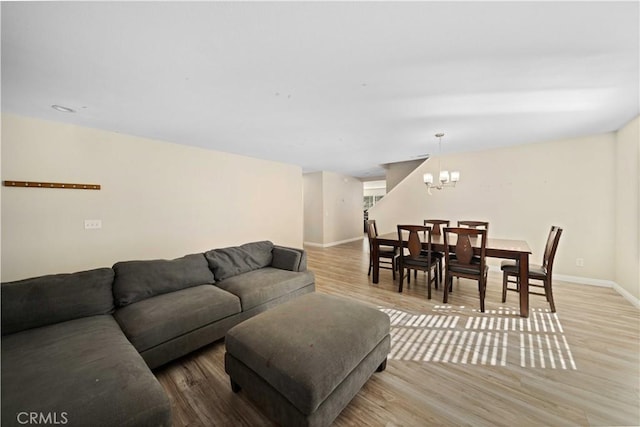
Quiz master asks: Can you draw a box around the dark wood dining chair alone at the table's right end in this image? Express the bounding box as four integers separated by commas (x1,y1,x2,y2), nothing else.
500,225,562,313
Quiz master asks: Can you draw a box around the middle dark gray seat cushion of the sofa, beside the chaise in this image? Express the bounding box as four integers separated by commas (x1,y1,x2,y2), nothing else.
114,285,240,352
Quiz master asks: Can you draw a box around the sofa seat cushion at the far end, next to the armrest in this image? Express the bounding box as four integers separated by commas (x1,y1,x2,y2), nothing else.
216,267,315,311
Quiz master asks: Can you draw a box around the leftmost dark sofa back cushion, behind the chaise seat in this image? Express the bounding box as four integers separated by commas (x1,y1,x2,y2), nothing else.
0,268,113,335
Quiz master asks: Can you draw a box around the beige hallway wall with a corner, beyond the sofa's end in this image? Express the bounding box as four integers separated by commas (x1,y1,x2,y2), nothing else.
304,172,363,246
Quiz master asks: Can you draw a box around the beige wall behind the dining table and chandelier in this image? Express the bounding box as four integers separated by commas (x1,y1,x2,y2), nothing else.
369,133,616,282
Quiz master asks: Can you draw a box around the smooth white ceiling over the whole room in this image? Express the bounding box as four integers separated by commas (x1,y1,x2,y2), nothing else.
1,1,640,178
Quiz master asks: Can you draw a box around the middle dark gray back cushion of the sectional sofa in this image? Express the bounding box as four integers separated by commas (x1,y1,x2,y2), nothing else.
113,254,214,307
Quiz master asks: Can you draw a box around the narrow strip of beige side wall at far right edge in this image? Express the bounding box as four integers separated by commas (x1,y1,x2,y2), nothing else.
615,117,640,299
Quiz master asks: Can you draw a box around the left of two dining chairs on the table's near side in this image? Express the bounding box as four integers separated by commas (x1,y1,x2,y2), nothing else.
398,225,438,299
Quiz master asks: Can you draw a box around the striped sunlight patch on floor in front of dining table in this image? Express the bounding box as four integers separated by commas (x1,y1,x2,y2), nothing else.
380,305,577,370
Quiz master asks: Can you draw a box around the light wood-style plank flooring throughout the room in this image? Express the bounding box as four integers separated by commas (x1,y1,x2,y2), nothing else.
155,241,640,427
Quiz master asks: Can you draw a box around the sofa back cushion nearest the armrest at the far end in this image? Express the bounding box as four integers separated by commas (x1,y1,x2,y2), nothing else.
204,240,273,280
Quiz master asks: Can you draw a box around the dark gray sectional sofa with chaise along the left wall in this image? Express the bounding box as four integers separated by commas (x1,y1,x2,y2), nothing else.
0,241,315,426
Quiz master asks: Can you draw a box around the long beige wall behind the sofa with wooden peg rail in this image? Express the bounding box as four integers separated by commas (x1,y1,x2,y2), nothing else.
1,115,303,281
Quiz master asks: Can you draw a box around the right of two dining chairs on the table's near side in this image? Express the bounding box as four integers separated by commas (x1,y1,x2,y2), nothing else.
442,227,489,313
